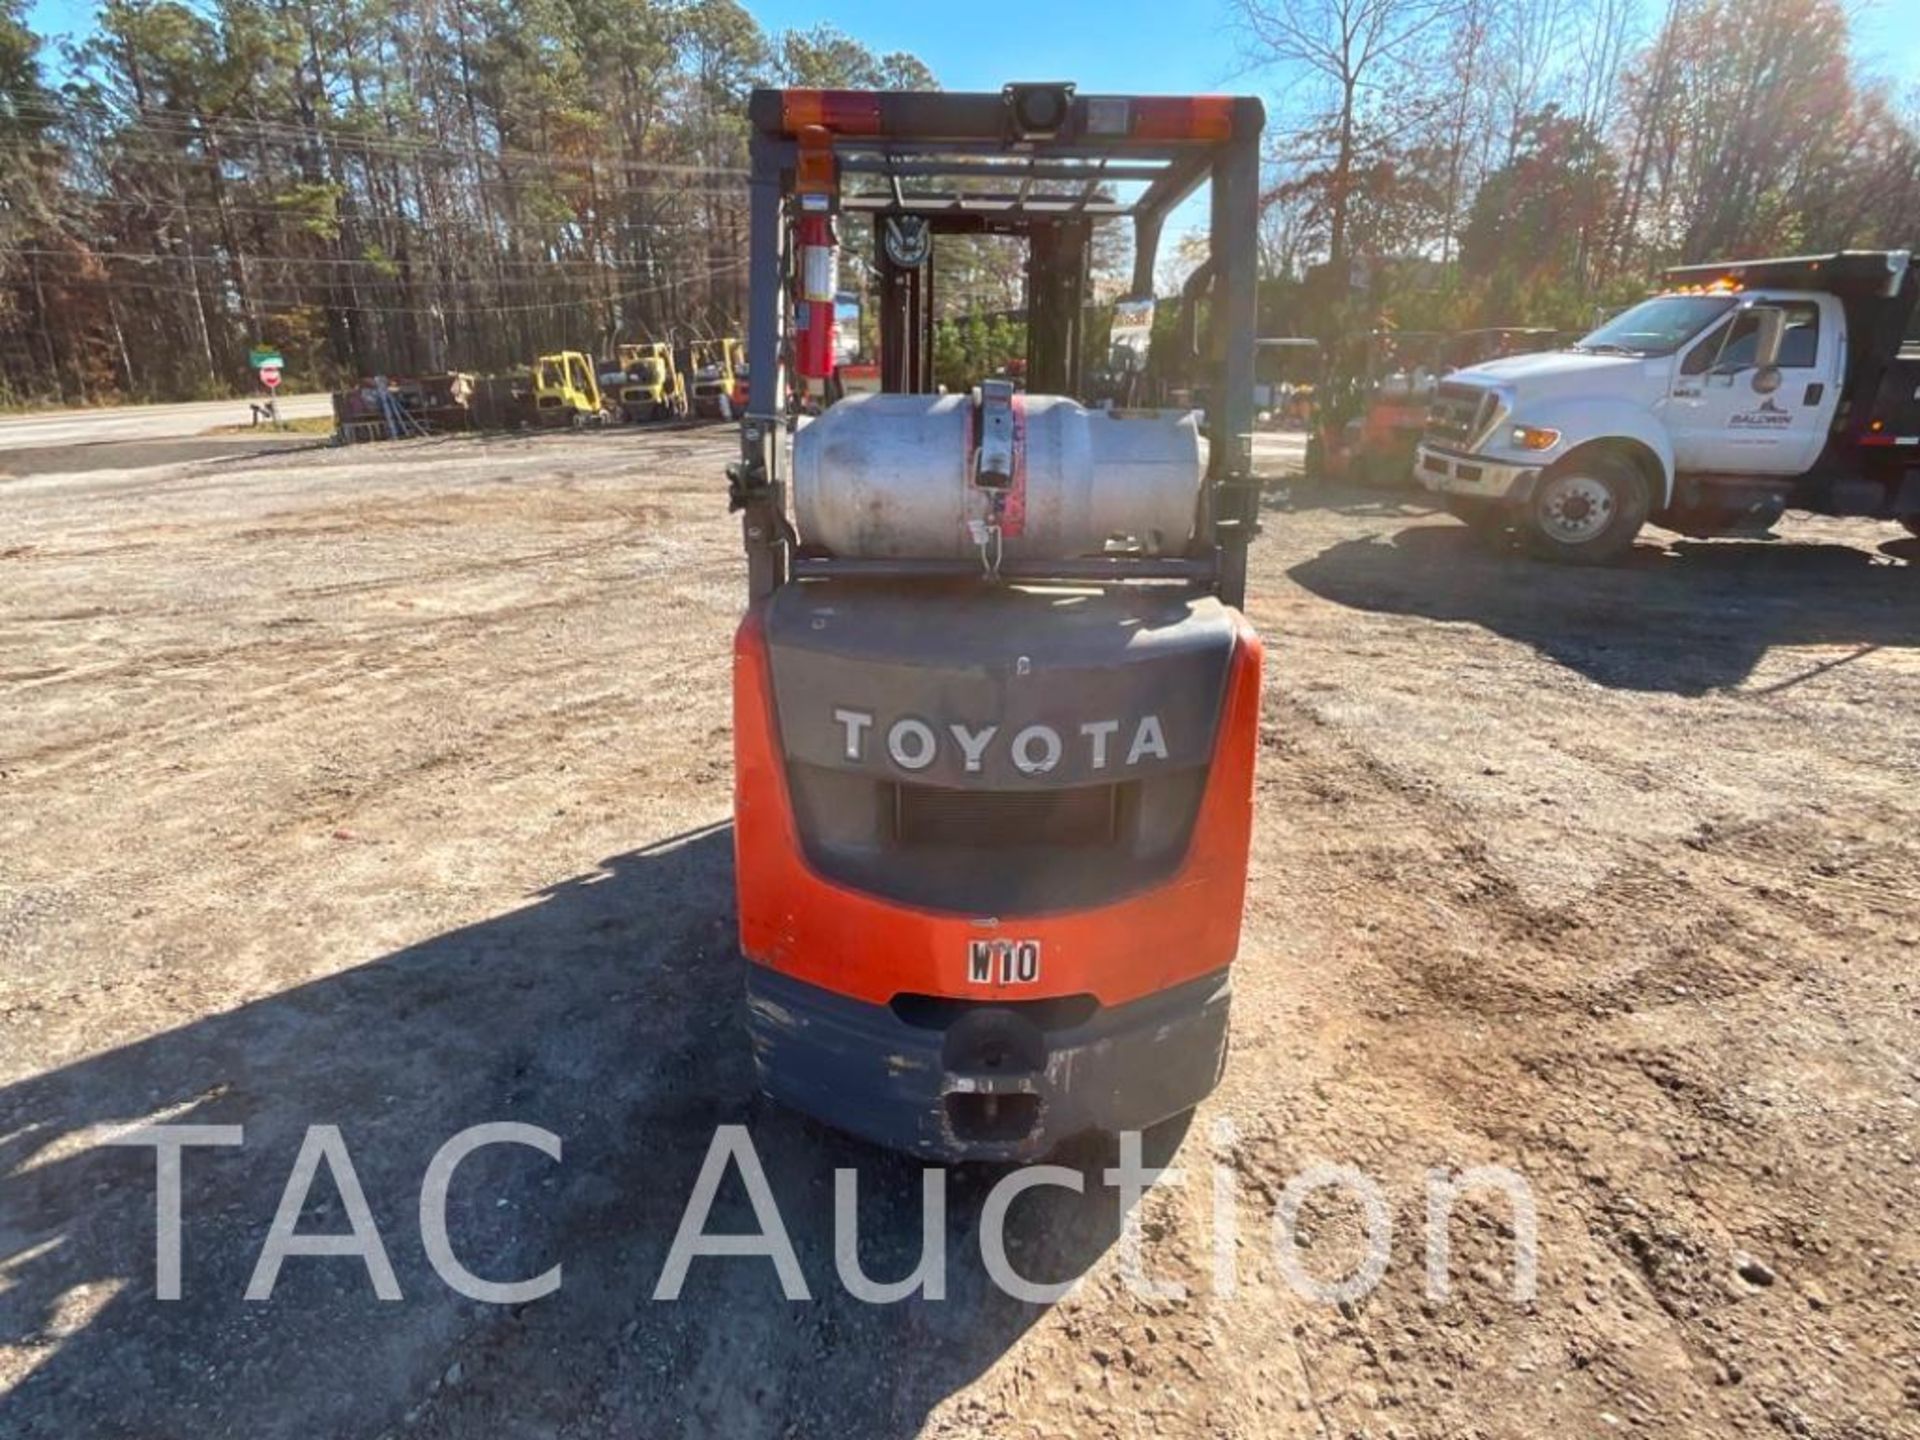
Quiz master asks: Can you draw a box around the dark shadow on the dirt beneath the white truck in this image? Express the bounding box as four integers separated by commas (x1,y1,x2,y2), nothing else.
1288,511,1920,695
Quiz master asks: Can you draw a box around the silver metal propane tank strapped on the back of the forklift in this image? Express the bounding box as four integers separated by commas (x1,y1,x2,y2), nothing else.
793,394,1206,561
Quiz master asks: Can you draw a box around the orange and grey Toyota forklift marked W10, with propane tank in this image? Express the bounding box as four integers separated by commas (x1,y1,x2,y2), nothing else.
728,84,1263,1162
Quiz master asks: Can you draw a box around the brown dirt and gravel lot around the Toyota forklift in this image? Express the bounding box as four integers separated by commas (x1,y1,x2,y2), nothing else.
0,430,1920,1440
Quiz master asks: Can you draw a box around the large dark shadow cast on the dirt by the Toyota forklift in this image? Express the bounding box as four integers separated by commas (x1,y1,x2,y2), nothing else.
0,828,1152,1440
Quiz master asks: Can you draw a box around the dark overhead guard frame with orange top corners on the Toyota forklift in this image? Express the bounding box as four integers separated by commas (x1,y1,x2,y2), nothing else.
730,83,1265,607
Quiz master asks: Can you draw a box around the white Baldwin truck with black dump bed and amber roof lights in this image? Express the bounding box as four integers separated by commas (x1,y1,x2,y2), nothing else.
1413,250,1920,564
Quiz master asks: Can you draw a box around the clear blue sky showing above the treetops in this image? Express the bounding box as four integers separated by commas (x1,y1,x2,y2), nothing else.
29,0,1920,102
